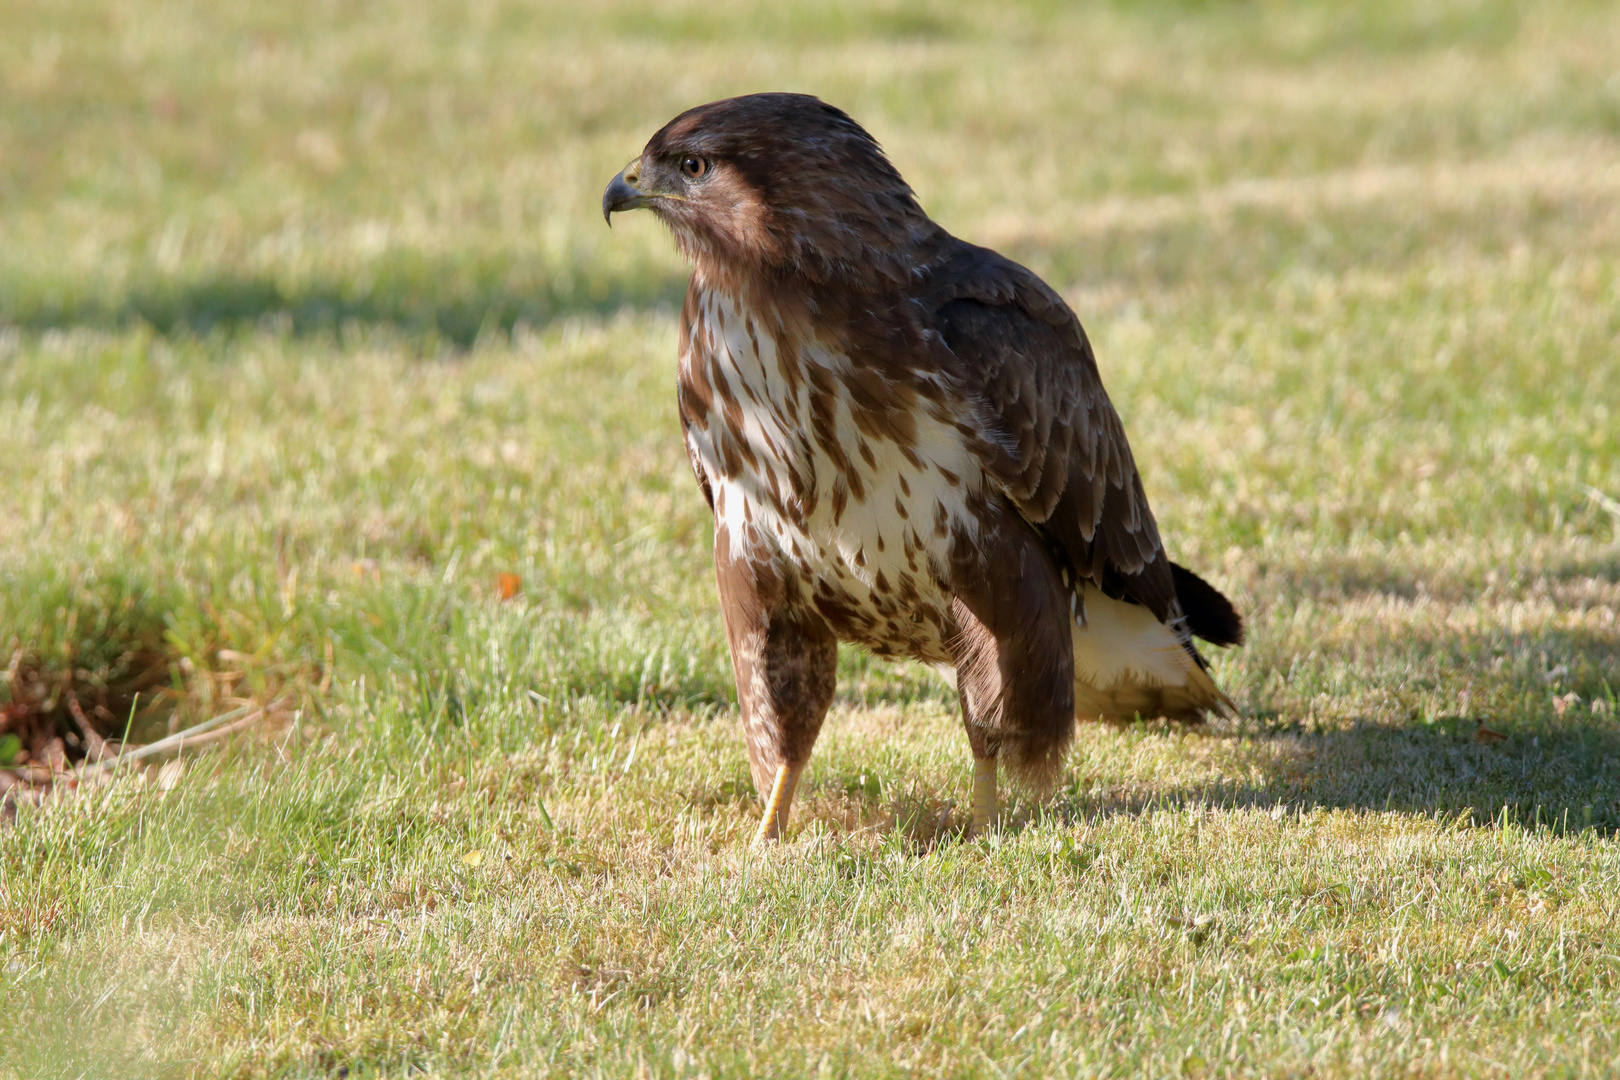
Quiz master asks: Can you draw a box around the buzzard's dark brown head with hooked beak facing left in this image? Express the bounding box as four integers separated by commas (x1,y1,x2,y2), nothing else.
603,94,938,282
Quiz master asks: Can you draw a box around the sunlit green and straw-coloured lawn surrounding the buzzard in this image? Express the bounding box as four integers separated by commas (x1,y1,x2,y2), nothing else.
0,0,1620,1080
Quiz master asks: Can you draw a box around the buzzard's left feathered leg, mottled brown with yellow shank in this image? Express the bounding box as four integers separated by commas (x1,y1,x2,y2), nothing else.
714,531,838,844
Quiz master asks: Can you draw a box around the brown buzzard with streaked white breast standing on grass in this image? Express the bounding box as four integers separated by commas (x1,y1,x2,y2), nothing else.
603,94,1243,840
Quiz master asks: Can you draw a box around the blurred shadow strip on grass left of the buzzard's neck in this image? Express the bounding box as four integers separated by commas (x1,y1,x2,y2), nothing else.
0,256,685,348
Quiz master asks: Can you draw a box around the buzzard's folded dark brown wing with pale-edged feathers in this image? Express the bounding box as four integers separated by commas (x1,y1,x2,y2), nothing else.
920,241,1181,622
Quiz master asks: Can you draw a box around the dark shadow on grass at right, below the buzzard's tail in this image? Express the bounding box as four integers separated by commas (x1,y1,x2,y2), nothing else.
1050,615,1620,836
